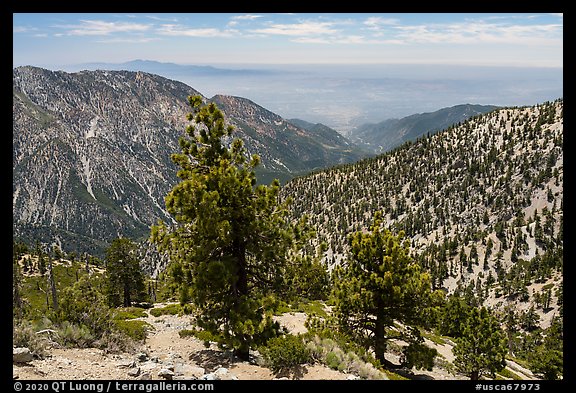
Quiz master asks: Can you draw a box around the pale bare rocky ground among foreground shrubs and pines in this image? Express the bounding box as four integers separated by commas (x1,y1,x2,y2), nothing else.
12,304,534,380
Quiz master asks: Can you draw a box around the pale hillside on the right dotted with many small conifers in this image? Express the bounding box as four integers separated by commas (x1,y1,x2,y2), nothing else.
283,100,564,327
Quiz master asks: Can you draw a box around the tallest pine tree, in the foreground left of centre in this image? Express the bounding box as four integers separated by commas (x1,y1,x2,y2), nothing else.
151,96,302,360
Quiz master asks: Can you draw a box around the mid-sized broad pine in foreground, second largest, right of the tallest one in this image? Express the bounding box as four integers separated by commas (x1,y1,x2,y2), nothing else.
334,212,442,367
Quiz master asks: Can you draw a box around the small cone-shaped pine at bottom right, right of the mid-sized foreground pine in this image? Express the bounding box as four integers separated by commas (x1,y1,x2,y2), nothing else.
453,307,508,380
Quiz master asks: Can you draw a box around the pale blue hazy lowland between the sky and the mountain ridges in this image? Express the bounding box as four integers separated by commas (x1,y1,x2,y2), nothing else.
59,60,563,136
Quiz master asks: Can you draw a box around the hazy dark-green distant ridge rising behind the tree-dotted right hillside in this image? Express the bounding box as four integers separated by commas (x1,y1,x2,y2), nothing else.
348,104,498,153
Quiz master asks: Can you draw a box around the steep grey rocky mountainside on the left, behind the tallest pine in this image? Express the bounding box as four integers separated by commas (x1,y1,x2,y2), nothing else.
12,67,359,255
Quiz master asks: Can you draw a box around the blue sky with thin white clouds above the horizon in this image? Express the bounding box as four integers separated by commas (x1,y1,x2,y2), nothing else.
13,13,563,68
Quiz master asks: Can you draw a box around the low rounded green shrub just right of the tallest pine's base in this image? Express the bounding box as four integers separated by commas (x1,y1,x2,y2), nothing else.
259,334,312,373
